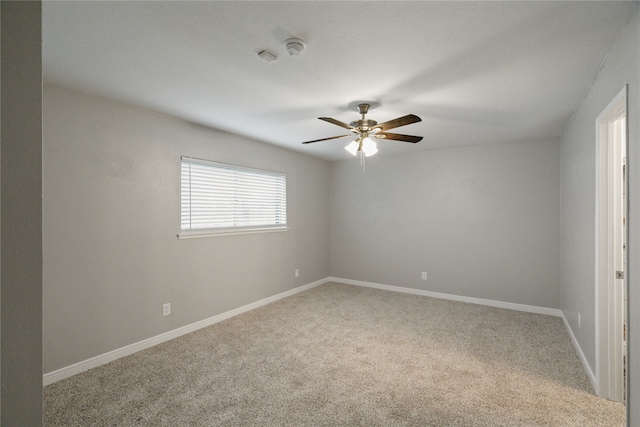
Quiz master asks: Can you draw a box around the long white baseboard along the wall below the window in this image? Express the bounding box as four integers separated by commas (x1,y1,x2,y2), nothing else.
42,278,328,386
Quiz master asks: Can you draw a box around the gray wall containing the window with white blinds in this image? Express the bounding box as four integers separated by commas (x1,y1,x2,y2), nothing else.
43,85,330,372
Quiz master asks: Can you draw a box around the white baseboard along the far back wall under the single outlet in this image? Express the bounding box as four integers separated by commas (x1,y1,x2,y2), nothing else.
329,277,563,317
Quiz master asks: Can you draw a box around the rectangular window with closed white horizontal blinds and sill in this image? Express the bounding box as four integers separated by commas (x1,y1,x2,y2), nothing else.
179,157,287,238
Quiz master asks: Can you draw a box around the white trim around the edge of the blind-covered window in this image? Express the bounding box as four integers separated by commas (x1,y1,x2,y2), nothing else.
177,156,289,240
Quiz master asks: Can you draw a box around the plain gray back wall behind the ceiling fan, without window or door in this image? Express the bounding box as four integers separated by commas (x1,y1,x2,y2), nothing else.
331,139,560,308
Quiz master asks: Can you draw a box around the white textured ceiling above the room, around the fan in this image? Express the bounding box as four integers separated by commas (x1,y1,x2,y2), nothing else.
43,1,636,160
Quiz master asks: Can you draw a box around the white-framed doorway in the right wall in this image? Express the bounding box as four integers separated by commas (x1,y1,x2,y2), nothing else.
596,86,627,402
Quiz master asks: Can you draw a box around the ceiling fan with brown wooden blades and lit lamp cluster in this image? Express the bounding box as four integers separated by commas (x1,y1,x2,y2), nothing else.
303,103,422,157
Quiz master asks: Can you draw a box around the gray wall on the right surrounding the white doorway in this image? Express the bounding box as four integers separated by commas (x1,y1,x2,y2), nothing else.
561,4,640,426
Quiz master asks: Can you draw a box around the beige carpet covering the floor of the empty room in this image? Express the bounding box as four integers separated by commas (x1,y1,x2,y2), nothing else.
44,283,625,427
